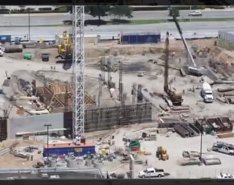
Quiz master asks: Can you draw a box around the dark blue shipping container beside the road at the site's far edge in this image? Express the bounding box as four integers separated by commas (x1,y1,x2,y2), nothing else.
121,33,161,44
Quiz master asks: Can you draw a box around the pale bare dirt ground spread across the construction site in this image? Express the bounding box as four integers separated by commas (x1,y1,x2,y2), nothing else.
0,39,234,178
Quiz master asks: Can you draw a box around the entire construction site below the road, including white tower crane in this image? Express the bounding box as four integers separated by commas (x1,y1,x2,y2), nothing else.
0,6,234,179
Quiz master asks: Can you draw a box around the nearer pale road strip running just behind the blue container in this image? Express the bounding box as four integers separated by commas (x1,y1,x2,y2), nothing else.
0,22,234,40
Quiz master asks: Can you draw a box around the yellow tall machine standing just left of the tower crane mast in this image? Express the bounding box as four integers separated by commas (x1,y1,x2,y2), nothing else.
56,31,72,69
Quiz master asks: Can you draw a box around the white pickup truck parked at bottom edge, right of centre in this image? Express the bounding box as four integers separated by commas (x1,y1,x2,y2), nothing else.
138,168,166,178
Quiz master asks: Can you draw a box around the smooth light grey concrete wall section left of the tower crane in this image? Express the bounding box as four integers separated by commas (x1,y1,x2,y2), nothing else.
7,113,63,138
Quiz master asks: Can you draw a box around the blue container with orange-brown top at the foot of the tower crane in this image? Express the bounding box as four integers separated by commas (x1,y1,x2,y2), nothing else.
43,144,95,157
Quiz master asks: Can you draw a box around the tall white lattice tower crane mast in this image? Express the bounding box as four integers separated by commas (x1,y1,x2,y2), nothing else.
72,5,85,142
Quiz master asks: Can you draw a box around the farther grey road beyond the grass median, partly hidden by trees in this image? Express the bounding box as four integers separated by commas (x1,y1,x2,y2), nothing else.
0,10,234,26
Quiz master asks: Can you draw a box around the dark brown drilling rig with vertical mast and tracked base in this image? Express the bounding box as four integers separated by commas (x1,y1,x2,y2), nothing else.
164,32,183,106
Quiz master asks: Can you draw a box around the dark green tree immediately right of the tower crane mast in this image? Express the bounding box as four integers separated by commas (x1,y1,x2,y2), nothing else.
85,5,110,22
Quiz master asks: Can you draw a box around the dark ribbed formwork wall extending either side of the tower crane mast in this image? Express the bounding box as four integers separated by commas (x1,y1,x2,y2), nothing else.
64,103,152,135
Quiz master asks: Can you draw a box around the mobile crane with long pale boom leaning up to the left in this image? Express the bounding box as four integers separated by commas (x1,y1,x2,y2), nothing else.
172,11,203,76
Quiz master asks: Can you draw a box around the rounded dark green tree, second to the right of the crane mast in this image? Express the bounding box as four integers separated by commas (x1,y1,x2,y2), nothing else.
109,5,132,19
